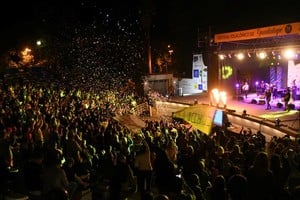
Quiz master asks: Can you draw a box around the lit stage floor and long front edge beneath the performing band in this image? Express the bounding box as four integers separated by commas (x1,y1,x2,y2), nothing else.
170,93,300,140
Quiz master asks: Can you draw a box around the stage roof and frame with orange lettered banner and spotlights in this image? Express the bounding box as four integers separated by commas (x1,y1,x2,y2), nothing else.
213,22,300,95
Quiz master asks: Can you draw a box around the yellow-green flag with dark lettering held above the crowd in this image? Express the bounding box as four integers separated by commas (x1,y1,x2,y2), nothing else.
173,104,216,135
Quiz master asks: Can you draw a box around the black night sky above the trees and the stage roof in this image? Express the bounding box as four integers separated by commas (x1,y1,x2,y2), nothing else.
0,0,300,72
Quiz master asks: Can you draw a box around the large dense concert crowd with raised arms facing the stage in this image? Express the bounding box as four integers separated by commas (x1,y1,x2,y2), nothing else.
0,67,300,200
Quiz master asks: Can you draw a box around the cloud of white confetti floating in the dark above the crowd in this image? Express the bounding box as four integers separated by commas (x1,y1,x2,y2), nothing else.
50,9,147,94
